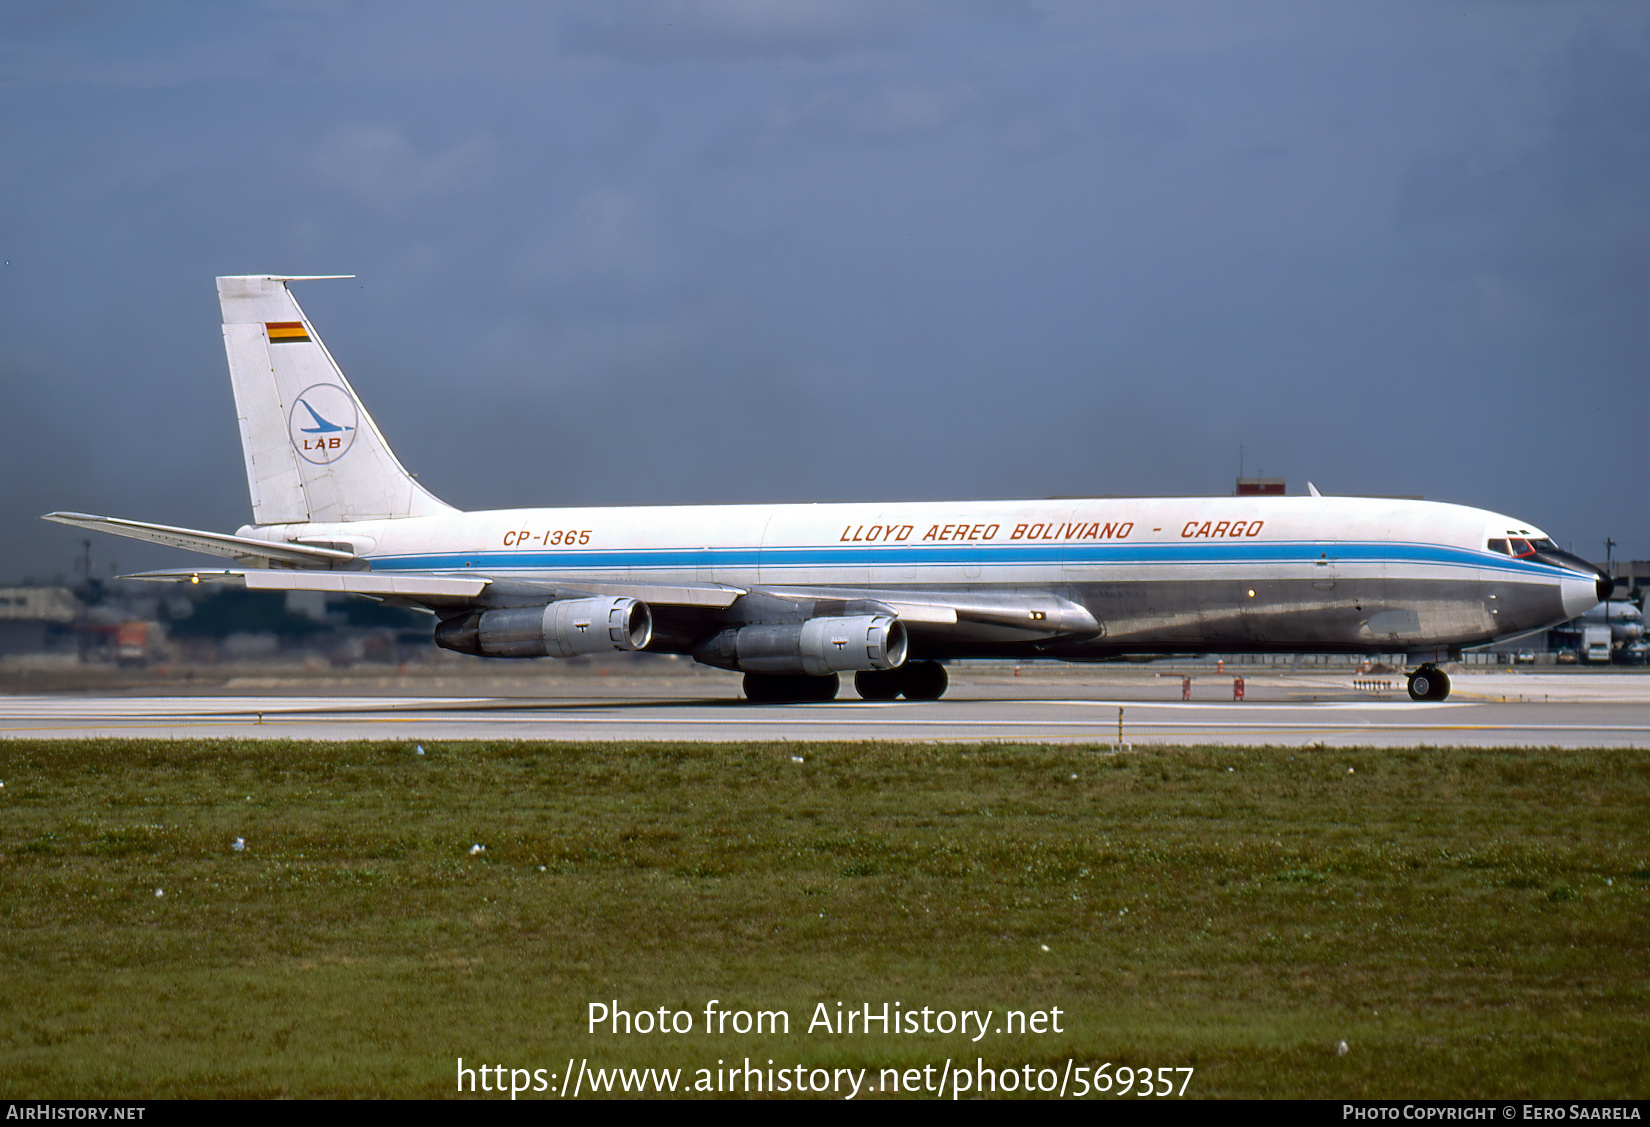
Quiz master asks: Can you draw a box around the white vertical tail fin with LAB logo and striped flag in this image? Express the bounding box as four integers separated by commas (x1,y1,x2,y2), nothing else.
218,274,454,525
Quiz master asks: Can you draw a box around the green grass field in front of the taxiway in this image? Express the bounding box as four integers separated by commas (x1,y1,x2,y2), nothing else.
0,741,1650,1097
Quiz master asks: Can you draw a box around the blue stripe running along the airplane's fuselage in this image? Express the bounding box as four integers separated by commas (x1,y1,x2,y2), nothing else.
368,541,1569,579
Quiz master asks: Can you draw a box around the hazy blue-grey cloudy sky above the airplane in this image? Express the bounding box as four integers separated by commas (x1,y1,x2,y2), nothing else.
0,0,1650,581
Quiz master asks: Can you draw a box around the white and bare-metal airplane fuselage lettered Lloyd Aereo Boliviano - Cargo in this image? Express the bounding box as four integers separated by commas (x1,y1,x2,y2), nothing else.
243,497,1596,657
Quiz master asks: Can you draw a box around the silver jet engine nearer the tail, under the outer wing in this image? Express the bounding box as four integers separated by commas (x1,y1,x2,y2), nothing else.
436,599,653,657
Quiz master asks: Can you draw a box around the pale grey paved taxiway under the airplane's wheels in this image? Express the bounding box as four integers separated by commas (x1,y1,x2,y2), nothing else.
0,672,1650,747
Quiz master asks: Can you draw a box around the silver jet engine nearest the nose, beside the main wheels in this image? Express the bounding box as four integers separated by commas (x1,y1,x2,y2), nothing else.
693,614,909,677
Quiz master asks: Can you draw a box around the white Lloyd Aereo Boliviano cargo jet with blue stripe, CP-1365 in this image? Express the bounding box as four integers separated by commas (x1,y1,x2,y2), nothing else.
45,274,1610,701
